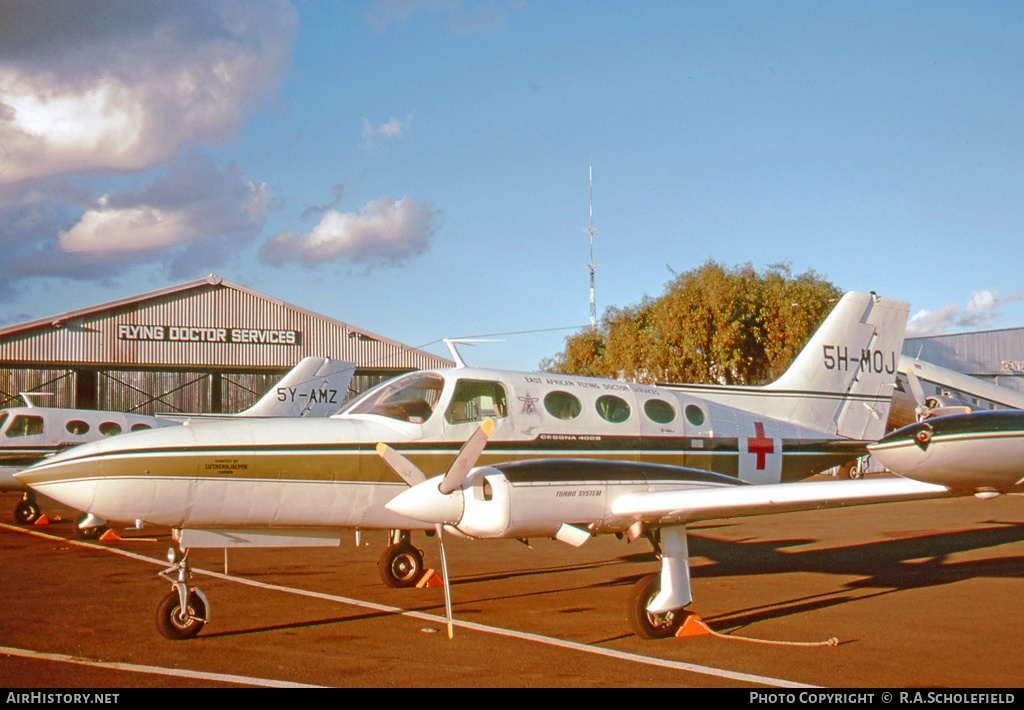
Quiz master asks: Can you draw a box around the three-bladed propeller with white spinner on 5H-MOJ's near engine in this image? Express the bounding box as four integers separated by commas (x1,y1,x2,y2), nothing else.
377,418,495,638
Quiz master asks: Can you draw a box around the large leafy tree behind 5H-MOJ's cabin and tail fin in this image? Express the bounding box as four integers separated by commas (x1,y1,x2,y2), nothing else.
541,260,842,384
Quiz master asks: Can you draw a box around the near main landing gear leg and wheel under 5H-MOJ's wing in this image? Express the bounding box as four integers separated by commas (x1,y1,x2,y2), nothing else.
627,526,693,638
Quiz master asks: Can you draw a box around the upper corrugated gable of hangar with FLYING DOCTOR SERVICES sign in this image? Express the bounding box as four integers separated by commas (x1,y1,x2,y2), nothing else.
0,274,454,371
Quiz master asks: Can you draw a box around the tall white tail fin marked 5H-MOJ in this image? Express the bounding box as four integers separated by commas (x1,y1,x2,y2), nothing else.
765,292,910,441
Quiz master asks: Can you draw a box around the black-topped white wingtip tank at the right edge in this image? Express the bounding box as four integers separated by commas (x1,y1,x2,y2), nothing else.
867,409,1024,489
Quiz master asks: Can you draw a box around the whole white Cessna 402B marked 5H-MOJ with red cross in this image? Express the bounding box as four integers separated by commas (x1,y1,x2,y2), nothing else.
18,293,966,638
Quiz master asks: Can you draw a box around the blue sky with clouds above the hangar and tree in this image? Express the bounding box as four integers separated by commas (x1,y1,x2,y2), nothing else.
0,0,1024,370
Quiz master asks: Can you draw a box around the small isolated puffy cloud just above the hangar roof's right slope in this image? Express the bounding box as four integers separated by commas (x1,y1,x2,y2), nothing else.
260,197,439,267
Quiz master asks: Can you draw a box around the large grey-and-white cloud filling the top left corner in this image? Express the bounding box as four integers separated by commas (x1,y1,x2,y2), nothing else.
0,0,297,182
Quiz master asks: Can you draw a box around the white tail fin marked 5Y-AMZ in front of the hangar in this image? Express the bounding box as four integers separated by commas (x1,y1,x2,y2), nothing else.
236,358,355,417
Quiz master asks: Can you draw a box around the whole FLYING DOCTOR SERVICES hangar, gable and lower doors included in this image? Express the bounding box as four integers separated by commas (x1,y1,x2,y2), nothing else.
0,275,454,414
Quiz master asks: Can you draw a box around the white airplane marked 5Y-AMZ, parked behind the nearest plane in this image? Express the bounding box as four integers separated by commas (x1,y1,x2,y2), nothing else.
0,357,353,530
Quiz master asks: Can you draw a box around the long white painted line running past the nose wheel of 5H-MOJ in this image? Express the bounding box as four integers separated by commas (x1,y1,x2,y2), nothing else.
0,523,816,687
